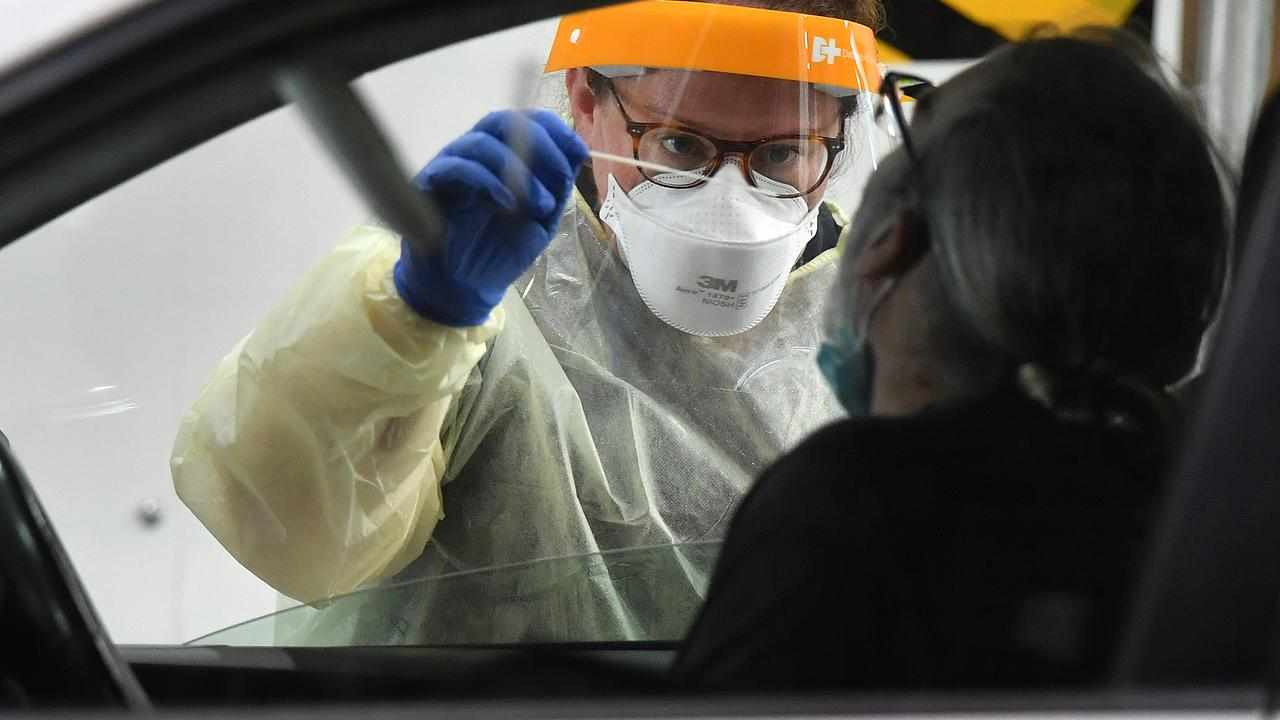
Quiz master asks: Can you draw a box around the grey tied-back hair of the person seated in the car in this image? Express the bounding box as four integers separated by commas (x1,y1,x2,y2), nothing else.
842,31,1229,420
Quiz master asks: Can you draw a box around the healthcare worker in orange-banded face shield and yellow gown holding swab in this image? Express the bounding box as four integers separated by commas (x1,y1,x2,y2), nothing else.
172,0,879,643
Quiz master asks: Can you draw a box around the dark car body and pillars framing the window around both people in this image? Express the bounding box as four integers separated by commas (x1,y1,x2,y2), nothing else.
0,0,1280,716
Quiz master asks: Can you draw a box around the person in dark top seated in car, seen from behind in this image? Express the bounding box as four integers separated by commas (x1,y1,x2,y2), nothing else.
676,29,1229,691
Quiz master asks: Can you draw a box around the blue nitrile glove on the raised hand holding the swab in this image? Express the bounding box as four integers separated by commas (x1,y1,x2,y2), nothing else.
396,110,588,327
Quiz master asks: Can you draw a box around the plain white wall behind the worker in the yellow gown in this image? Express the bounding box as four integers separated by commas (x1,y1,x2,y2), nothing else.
0,0,956,643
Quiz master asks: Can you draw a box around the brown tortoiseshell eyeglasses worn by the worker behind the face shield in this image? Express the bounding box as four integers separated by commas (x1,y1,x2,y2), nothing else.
608,82,845,197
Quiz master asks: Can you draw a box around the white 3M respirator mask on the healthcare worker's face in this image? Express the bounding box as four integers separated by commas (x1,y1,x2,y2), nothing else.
600,165,818,337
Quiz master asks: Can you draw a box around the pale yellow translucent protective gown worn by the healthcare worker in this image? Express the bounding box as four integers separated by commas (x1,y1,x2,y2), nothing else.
172,190,841,644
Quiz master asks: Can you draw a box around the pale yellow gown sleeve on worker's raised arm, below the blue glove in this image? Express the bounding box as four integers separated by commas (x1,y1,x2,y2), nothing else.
170,227,504,602
